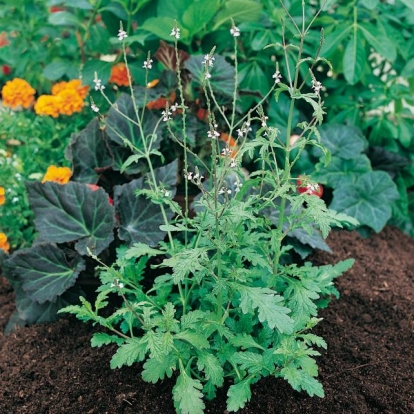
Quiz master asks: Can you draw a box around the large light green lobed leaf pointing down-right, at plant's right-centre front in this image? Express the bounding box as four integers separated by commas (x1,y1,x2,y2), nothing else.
232,283,294,333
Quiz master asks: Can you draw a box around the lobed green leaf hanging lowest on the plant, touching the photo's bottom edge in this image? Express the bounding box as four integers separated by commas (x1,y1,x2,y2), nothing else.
173,373,205,414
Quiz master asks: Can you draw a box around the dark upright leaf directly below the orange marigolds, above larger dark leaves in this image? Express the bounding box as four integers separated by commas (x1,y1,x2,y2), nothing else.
66,119,113,183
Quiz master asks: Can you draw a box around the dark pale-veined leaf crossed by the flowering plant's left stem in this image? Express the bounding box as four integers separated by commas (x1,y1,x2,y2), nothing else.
114,160,178,246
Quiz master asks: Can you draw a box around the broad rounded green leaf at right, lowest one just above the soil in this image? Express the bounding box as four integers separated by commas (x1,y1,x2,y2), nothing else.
329,171,399,232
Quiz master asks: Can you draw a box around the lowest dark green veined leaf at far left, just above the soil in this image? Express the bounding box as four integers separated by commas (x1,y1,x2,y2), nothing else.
8,243,85,304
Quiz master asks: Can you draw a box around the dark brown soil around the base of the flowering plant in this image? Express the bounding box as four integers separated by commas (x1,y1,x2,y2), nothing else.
0,228,414,414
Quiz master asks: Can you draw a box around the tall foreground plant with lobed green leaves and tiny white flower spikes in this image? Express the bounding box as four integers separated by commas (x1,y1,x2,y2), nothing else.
58,5,357,414
